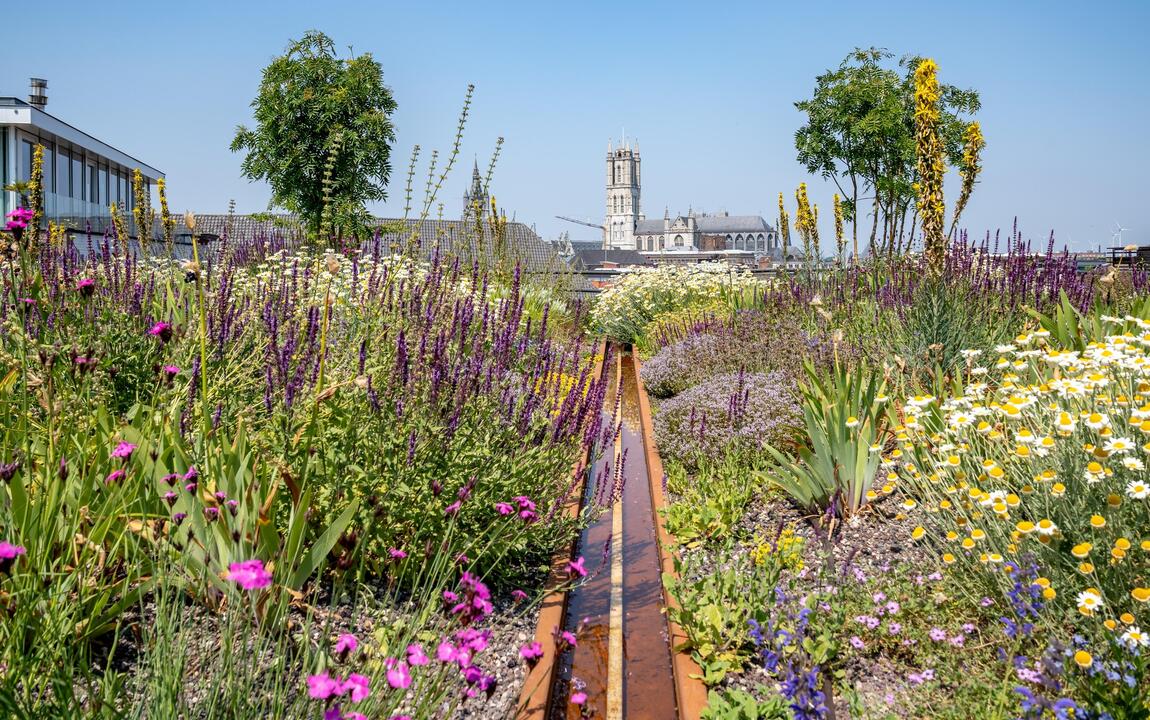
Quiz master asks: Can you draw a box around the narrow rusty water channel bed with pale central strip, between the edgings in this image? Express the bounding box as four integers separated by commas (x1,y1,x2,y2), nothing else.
550,351,680,720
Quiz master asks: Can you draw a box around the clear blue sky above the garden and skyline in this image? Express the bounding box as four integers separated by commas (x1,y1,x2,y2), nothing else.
0,0,1150,250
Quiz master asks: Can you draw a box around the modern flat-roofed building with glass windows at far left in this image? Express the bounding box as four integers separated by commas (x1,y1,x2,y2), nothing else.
0,78,163,235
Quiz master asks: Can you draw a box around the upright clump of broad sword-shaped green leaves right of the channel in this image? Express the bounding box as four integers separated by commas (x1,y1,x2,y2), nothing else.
766,356,886,515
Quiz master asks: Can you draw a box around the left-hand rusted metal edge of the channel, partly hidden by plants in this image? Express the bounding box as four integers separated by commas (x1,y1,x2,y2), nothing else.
515,339,607,720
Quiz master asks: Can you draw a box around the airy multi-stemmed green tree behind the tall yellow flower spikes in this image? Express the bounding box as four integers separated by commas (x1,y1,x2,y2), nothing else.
795,47,980,253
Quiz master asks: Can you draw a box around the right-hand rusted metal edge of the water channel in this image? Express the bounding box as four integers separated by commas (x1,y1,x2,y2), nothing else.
631,350,707,720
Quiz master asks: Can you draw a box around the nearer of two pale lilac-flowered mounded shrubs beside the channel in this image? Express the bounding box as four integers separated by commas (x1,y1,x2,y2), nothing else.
654,372,799,467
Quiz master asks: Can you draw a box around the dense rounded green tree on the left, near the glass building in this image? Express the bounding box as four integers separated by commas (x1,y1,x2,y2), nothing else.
231,30,396,240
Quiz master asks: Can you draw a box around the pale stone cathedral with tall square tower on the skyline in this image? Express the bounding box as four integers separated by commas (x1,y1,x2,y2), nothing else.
603,140,781,258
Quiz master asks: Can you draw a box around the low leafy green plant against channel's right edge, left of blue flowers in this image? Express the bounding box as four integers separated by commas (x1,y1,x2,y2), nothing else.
662,552,781,685
